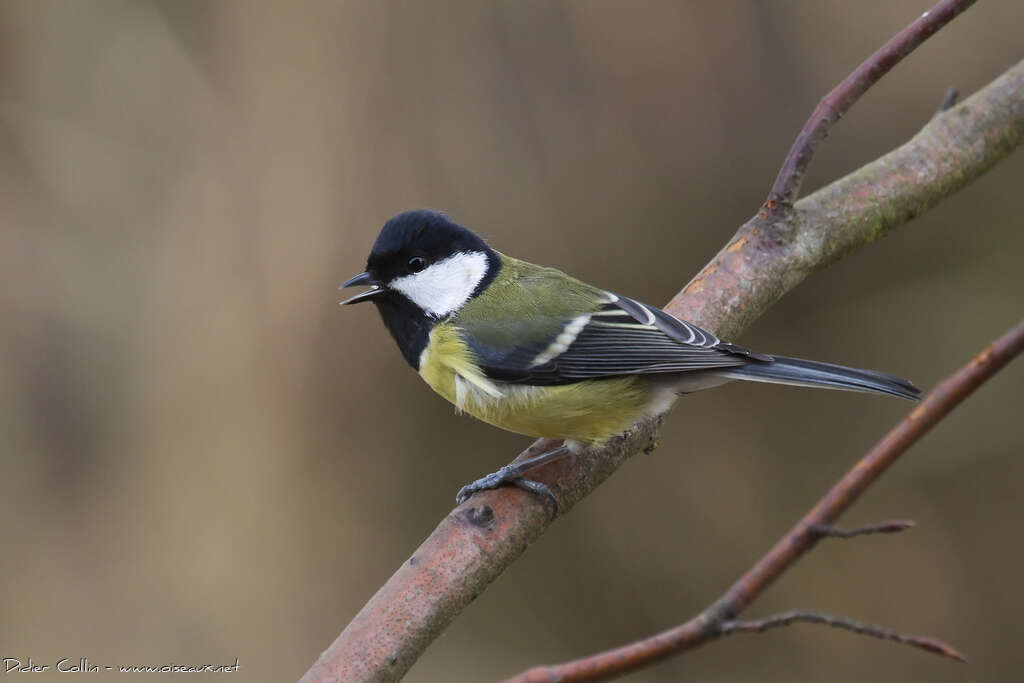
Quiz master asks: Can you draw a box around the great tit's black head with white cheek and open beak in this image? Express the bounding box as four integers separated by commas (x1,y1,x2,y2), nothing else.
342,209,501,368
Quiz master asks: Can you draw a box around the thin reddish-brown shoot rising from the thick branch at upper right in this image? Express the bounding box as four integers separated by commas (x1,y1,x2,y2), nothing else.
765,0,976,216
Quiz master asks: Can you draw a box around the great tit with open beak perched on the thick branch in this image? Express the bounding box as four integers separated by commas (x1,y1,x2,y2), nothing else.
341,210,921,510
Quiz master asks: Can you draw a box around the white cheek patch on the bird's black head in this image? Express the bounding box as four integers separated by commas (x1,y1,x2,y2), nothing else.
389,251,487,317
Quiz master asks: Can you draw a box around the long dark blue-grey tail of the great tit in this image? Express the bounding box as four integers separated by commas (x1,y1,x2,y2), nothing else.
723,355,921,400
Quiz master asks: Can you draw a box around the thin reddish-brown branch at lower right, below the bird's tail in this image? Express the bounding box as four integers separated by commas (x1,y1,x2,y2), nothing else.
509,321,1024,683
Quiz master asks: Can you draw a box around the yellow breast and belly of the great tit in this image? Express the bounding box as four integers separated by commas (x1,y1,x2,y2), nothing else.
420,323,659,444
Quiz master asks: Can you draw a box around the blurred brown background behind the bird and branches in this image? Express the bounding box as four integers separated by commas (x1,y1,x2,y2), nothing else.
0,0,1024,682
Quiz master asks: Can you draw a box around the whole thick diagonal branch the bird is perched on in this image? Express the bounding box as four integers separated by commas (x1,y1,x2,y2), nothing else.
302,45,1024,682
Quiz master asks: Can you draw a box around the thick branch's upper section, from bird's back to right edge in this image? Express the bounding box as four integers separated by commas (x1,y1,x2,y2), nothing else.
666,61,1024,339
